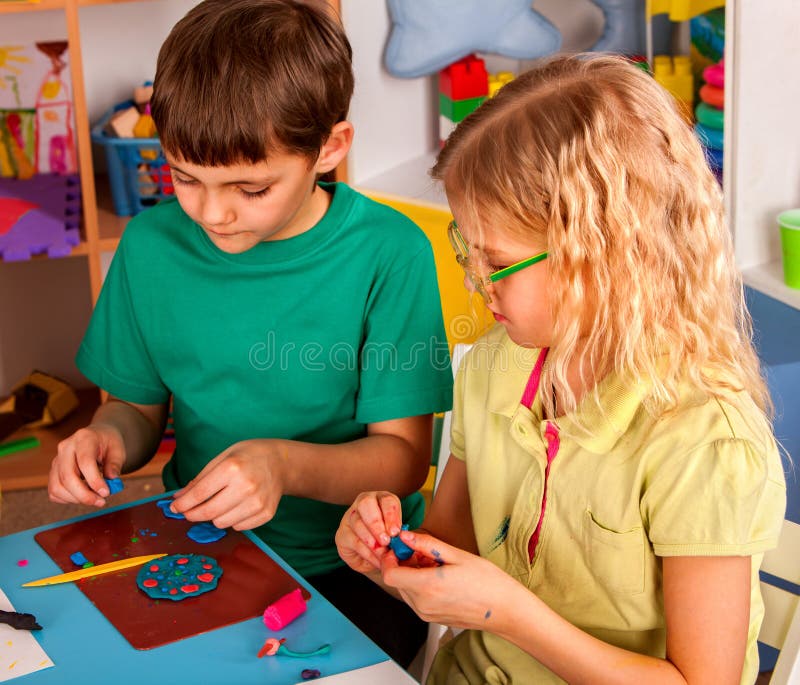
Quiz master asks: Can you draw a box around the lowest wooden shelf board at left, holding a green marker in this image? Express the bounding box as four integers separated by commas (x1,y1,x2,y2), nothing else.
0,388,169,492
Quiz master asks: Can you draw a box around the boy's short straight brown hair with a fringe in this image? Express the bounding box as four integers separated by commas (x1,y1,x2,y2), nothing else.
152,0,353,166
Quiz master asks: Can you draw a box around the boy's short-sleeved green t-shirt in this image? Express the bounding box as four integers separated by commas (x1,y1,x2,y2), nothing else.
77,184,452,576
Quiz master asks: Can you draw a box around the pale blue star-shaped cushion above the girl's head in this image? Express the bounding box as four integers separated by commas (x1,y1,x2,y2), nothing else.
384,0,561,78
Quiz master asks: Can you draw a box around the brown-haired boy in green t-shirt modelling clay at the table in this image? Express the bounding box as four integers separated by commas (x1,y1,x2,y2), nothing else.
50,0,452,665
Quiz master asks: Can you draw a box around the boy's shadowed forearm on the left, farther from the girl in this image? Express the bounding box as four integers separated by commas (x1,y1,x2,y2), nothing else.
92,398,166,473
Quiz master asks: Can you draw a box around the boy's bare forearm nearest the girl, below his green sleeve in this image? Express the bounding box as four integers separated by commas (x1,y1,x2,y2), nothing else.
275,434,430,504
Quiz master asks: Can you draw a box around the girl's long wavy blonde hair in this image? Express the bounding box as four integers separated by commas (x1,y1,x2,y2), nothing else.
431,54,772,416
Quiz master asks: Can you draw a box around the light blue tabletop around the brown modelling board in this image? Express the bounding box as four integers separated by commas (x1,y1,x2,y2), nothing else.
0,494,415,685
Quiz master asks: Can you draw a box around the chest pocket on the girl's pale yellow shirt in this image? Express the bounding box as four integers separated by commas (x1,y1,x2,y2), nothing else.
583,509,645,595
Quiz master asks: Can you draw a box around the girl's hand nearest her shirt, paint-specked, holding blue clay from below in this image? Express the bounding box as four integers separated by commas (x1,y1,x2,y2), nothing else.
382,531,529,633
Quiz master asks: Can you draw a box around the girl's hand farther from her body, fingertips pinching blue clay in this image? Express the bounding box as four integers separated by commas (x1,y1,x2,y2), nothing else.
336,491,402,573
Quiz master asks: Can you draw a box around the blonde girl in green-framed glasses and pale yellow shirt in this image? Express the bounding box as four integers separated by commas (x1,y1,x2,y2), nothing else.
337,55,785,685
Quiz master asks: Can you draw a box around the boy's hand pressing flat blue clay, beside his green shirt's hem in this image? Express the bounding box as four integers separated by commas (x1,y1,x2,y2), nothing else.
172,440,287,530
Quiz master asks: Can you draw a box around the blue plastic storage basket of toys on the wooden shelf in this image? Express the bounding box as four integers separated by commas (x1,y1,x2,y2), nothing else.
92,101,174,216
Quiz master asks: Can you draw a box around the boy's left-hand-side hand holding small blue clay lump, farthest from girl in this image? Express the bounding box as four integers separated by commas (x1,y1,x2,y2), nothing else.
47,423,125,507
